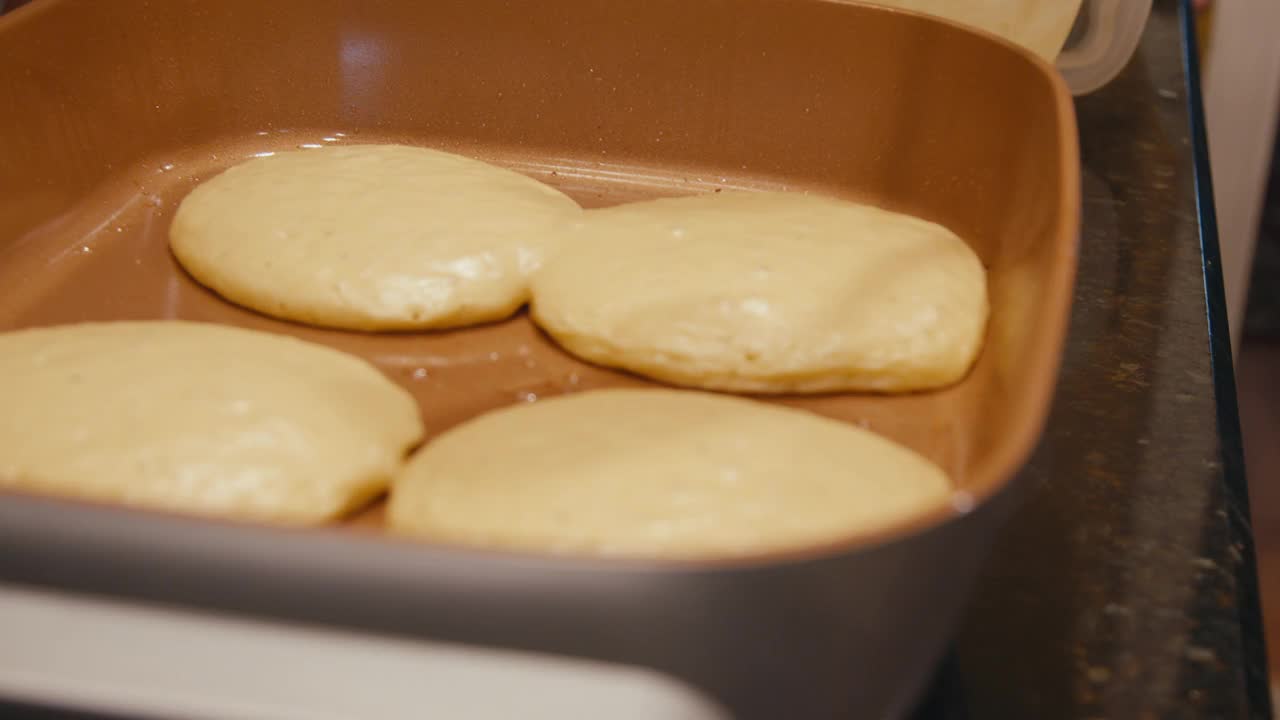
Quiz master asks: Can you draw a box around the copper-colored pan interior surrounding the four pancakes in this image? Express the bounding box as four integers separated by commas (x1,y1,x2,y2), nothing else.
0,0,1078,556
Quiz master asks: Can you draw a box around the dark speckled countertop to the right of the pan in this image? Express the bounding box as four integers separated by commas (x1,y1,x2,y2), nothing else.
922,1,1270,719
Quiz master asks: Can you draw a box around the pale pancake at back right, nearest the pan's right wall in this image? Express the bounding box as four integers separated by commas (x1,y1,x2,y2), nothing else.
531,192,988,393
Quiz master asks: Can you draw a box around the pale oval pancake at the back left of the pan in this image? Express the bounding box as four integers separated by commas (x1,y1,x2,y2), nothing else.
170,145,580,331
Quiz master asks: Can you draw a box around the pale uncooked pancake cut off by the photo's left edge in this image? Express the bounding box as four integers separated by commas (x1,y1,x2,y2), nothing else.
0,320,422,524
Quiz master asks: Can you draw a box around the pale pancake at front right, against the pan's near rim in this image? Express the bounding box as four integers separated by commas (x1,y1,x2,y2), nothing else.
388,389,950,559
